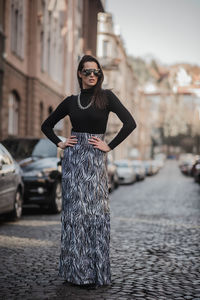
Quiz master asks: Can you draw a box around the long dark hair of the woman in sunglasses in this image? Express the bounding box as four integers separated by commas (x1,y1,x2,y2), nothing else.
77,55,108,109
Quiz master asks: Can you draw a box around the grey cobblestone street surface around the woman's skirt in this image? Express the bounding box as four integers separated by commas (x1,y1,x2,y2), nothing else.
0,161,200,300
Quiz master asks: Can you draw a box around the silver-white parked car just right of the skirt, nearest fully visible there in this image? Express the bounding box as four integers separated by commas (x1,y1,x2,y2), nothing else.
115,160,136,184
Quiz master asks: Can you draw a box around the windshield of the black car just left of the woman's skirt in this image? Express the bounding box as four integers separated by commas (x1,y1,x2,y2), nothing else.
32,139,57,157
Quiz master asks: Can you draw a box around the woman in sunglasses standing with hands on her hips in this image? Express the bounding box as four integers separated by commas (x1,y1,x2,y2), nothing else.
41,55,136,286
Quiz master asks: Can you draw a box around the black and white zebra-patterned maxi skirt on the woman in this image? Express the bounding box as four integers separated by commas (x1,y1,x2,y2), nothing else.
58,131,111,285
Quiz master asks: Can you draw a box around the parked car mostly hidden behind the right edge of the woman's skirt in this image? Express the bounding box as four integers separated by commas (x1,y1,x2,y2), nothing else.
107,155,119,192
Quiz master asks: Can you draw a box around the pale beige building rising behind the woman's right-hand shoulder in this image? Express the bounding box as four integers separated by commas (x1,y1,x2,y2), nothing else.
97,13,137,159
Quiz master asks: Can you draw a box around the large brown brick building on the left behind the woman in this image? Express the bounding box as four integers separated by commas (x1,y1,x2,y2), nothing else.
0,0,104,139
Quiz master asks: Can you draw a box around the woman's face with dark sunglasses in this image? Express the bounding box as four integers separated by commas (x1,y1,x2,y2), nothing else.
79,61,99,89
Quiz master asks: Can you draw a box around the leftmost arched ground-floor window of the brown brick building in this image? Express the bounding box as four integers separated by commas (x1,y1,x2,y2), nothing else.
8,92,20,135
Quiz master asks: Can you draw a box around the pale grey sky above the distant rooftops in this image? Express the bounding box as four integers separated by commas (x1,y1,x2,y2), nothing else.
106,0,200,66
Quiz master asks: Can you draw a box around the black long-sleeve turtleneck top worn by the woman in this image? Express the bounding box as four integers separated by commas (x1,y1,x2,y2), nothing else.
41,88,136,149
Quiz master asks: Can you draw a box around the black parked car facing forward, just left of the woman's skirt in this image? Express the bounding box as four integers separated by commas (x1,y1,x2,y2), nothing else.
3,137,65,213
